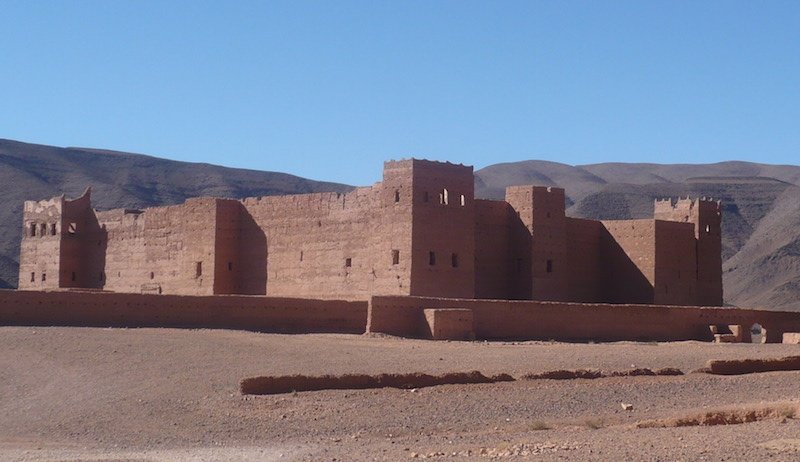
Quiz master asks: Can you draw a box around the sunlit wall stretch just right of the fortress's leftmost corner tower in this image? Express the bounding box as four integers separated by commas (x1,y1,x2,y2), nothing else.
97,198,220,295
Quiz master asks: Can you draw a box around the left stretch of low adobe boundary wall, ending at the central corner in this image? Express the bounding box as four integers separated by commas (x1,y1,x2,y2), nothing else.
0,290,367,333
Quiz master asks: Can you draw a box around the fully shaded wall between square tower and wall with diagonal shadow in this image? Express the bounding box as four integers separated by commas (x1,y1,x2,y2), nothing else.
565,218,607,302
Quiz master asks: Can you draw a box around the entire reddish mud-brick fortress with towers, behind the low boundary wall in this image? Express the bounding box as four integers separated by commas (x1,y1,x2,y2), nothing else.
19,159,722,306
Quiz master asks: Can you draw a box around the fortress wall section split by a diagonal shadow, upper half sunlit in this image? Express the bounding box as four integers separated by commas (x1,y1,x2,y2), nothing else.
601,220,656,303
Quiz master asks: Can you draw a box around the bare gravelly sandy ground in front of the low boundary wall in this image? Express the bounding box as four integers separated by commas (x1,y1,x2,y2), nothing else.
0,327,800,461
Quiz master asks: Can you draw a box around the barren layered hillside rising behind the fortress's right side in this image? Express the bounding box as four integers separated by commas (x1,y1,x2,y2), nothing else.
475,161,800,310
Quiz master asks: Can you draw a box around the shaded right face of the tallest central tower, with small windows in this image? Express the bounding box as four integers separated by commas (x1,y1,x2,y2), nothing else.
406,159,475,298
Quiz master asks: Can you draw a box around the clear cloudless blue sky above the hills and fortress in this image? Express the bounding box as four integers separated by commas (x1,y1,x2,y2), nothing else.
0,0,800,185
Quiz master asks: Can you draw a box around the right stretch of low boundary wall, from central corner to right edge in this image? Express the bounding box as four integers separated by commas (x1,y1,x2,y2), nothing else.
367,296,800,343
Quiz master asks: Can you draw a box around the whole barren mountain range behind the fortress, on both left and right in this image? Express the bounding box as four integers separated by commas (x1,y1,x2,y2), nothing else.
0,139,800,310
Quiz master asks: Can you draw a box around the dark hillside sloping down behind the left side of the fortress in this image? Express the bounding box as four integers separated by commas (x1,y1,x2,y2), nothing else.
0,139,352,287
